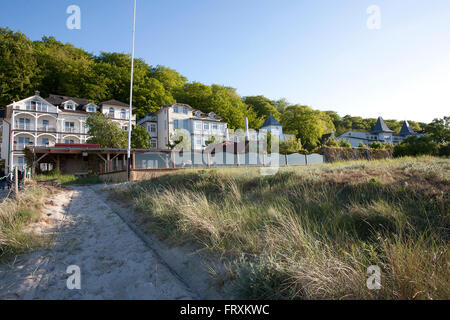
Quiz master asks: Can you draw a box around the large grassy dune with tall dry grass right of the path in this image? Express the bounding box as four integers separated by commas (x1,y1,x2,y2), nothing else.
113,157,450,299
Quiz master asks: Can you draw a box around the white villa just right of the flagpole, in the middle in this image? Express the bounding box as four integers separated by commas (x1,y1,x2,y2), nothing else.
138,103,228,150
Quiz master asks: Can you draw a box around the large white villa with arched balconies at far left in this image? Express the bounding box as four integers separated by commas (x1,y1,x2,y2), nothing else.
1,91,136,172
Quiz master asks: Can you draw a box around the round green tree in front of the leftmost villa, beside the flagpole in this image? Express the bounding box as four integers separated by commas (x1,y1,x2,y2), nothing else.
86,112,128,149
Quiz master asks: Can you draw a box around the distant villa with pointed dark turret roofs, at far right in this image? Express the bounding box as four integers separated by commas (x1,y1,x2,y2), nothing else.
337,117,420,147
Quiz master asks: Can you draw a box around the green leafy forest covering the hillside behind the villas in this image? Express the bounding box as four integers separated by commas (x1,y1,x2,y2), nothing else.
0,28,424,150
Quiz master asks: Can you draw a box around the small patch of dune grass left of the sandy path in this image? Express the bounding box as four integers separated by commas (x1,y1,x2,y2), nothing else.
0,185,55,262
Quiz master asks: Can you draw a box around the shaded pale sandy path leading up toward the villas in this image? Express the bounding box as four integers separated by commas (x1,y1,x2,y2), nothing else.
0,187,195,299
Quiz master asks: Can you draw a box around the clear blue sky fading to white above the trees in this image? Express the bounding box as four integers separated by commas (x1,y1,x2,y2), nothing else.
0,0,450,122
